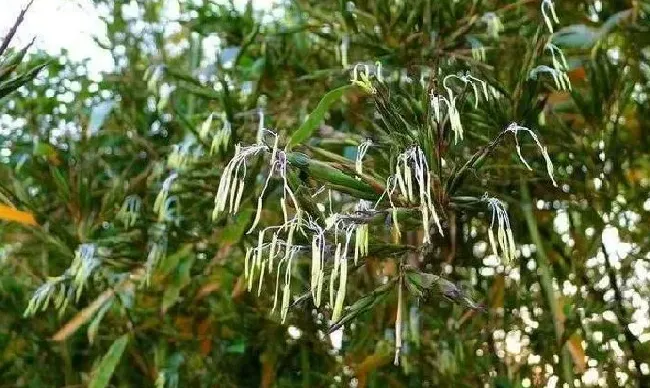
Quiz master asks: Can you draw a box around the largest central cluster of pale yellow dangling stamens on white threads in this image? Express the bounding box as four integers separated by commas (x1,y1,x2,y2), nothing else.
213,126,390,321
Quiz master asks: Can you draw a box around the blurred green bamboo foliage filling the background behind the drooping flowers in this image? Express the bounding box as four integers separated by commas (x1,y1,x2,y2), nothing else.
0,0,650,387
